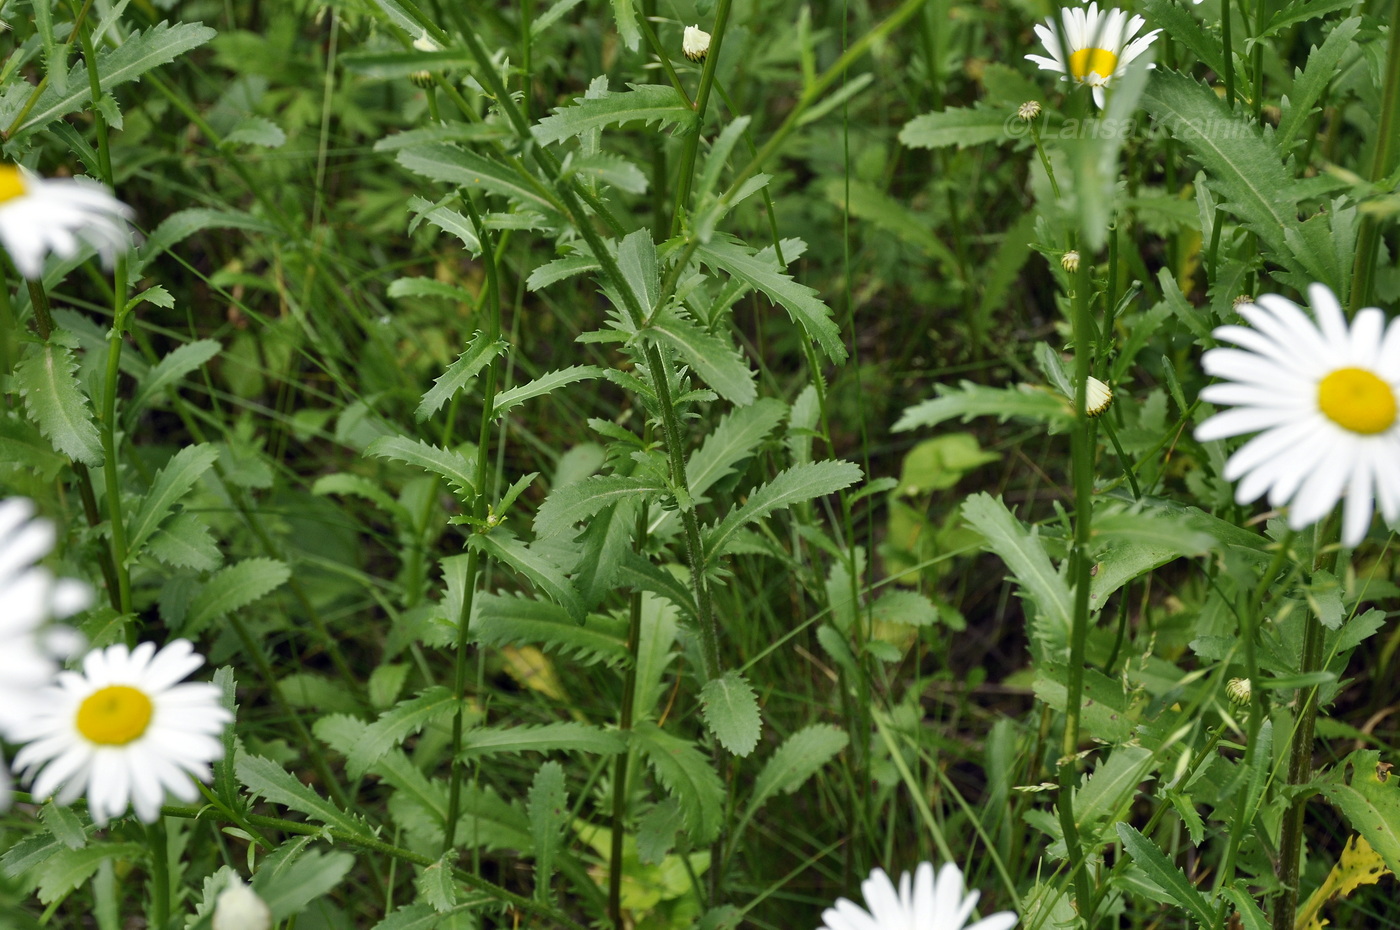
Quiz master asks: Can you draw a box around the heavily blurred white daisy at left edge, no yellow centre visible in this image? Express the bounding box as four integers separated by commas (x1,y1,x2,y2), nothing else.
0,497,92,810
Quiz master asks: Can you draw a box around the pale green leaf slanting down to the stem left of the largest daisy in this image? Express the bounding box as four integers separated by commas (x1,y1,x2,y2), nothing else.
963,493,1072,650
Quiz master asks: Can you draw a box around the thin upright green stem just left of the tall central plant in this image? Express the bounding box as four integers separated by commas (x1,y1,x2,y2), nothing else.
442,193,501,853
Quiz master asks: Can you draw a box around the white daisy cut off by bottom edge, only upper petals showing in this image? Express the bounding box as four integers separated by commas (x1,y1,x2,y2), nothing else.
820,863,1016,930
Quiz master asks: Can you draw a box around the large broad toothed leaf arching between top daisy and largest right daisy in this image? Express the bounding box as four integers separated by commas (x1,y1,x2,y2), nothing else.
1142,71,1298,265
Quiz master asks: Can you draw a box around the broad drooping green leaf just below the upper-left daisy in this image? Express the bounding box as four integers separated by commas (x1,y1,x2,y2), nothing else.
14,329,102,466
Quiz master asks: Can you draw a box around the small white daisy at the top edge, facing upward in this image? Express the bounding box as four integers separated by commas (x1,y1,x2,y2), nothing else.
1026,1,1161,108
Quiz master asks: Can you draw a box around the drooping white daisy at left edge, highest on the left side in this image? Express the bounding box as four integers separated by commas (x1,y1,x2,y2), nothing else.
0,165,132,279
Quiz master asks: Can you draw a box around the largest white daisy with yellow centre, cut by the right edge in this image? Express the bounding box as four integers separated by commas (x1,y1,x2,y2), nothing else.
1196,284,1400,546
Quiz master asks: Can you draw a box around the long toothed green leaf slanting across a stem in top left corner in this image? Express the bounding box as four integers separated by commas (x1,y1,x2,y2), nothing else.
10,22,217,141
